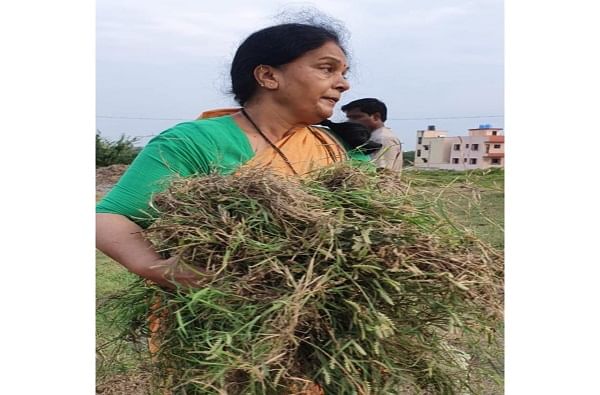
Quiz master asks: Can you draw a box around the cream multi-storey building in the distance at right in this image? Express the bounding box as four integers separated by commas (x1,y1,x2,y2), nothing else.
415,124,504,170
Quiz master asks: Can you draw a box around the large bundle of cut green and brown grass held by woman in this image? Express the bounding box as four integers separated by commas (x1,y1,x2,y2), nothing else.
106,165,503,394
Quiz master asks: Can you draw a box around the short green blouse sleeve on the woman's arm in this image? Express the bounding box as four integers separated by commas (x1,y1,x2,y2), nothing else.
96,123,217,228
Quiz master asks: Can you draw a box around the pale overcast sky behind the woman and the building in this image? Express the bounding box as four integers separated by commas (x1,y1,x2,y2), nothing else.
96,0,504,151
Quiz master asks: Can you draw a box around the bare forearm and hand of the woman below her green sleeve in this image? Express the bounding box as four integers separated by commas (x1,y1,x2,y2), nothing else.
96,213,199,287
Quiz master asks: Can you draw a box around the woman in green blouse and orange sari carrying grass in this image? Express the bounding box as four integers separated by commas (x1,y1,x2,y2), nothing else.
96,23,366,286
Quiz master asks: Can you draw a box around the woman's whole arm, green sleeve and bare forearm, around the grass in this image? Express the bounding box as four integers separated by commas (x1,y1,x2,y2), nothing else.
96,124,217,287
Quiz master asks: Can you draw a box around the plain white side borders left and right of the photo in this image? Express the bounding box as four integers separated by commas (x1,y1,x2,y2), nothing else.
0,0,600,395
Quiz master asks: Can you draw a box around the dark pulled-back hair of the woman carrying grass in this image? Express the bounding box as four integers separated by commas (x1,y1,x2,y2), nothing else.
231,23,346,106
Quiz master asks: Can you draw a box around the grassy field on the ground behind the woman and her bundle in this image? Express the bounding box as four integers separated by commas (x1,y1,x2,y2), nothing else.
96,170,504,395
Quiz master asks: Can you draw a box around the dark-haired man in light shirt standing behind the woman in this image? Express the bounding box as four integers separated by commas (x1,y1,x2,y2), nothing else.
342,98,402,171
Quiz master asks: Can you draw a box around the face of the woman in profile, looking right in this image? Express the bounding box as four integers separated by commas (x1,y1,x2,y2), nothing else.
275,42,350,124
